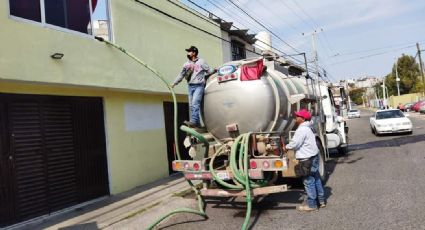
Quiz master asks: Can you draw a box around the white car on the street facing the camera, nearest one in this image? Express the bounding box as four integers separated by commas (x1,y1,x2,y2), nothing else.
370,109,413,135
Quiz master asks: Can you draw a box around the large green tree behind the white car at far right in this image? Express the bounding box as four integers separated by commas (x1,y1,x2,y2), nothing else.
385,54,421,96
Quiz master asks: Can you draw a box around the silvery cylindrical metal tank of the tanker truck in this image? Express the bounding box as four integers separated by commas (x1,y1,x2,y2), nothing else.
202,58,313,139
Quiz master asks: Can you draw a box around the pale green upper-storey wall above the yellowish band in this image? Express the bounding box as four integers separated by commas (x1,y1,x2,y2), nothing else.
0,0,222,93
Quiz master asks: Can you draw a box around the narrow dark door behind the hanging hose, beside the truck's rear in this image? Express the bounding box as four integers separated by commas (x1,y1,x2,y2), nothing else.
164,102,190,174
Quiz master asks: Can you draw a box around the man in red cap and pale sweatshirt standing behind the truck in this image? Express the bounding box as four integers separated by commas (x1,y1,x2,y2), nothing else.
283,109,326,211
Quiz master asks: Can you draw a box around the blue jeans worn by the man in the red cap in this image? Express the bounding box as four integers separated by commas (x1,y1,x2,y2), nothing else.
303,154,325,208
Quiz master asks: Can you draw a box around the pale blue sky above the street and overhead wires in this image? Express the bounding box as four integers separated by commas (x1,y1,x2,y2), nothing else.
181,0,425,82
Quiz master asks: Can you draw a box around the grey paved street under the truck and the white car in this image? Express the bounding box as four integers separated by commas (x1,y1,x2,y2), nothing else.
127,110,425,230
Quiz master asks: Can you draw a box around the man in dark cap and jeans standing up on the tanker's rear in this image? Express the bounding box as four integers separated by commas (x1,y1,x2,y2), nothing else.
171,46,216,128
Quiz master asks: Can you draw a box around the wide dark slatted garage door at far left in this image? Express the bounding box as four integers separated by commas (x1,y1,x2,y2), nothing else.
0,94,109,225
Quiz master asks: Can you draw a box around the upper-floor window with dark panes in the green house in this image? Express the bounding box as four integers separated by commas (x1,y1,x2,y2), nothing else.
9,0,110,40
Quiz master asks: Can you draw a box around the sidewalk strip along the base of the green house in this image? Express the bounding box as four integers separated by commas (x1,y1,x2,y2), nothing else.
13,174,199,230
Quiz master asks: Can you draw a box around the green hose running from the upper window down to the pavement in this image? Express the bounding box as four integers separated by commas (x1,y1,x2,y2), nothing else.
95,37,208,229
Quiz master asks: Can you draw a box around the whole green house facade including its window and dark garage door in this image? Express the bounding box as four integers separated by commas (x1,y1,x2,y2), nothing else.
0,0,223,226
